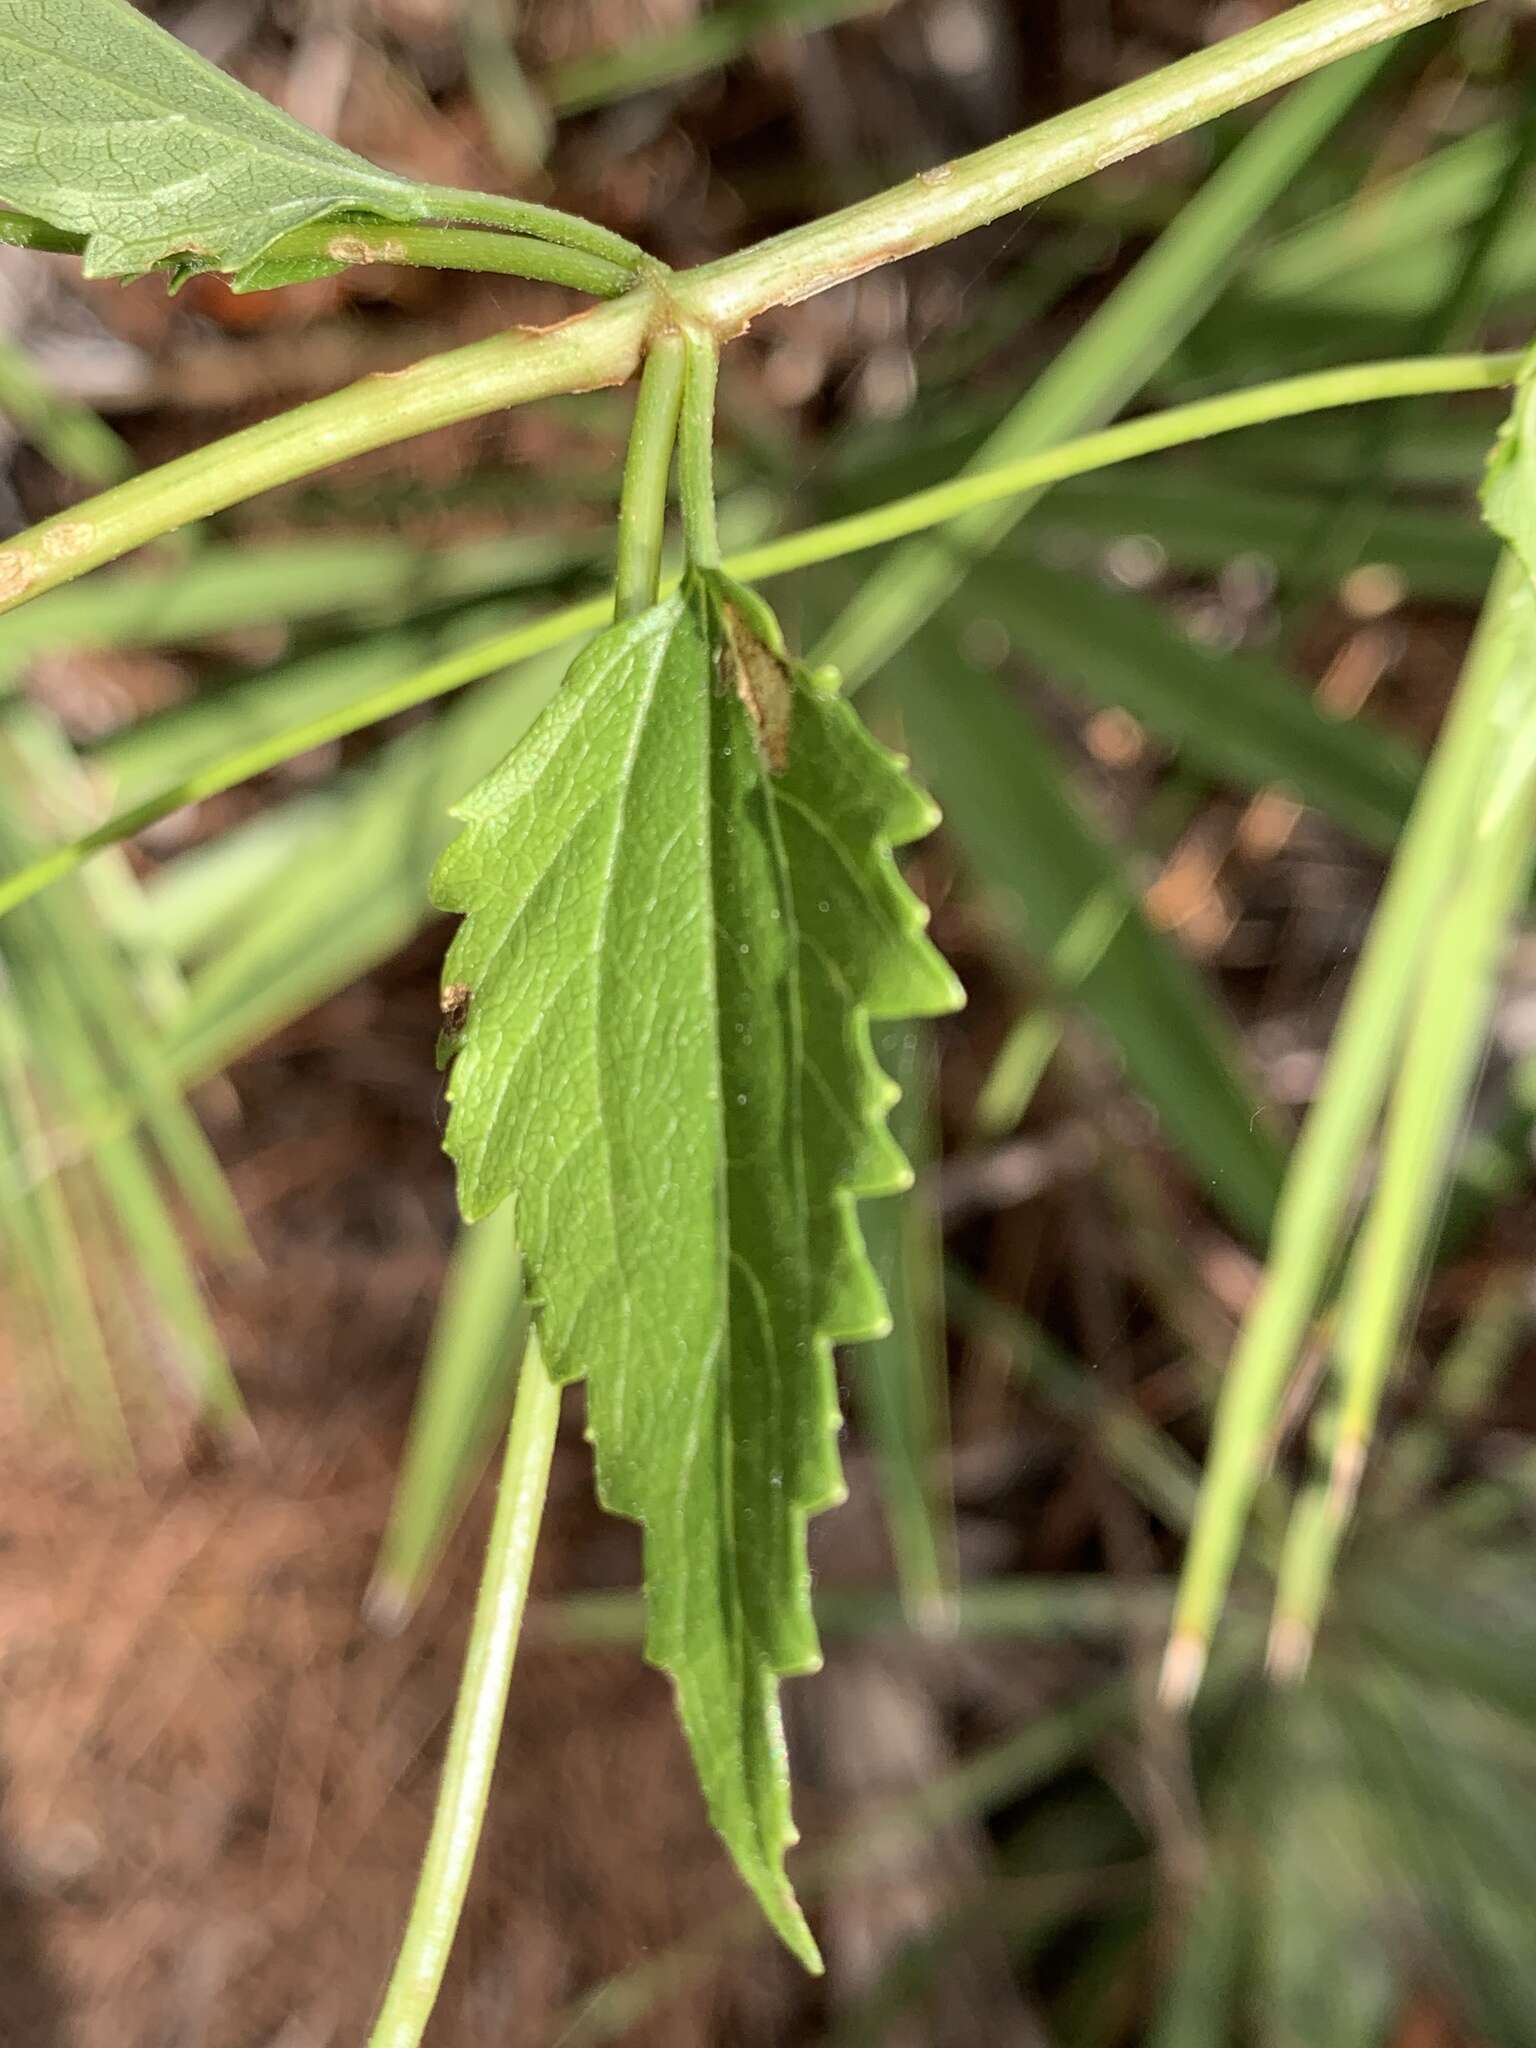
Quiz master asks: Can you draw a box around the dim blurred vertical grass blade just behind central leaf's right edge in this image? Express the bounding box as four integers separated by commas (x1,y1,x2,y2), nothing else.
848,1024,956,1630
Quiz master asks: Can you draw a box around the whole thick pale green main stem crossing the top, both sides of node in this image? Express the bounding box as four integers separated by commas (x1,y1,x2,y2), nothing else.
0,0,1477,610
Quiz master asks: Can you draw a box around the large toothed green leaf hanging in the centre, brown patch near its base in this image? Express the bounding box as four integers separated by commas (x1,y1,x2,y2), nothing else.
434,575,961,1964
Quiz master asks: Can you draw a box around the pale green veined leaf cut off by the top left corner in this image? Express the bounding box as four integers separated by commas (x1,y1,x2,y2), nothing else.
0,0,430,285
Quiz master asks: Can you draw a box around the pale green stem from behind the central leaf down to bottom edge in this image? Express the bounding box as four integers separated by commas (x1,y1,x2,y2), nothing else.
369,1337,559,2048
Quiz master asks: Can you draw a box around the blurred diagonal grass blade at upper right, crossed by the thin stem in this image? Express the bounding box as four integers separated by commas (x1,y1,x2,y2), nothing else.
817,49,1386,682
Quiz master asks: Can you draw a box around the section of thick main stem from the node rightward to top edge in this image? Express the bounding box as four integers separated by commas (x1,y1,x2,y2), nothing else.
676,0,1477,336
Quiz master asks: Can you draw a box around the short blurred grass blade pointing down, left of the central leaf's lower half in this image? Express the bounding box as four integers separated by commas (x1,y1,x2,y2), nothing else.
365,1202,539,1634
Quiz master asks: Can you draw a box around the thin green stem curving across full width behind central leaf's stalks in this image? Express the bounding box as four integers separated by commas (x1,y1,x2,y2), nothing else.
0,354,1520,918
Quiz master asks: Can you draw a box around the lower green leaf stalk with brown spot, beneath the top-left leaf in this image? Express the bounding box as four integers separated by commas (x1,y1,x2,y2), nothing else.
0,211,635,299
